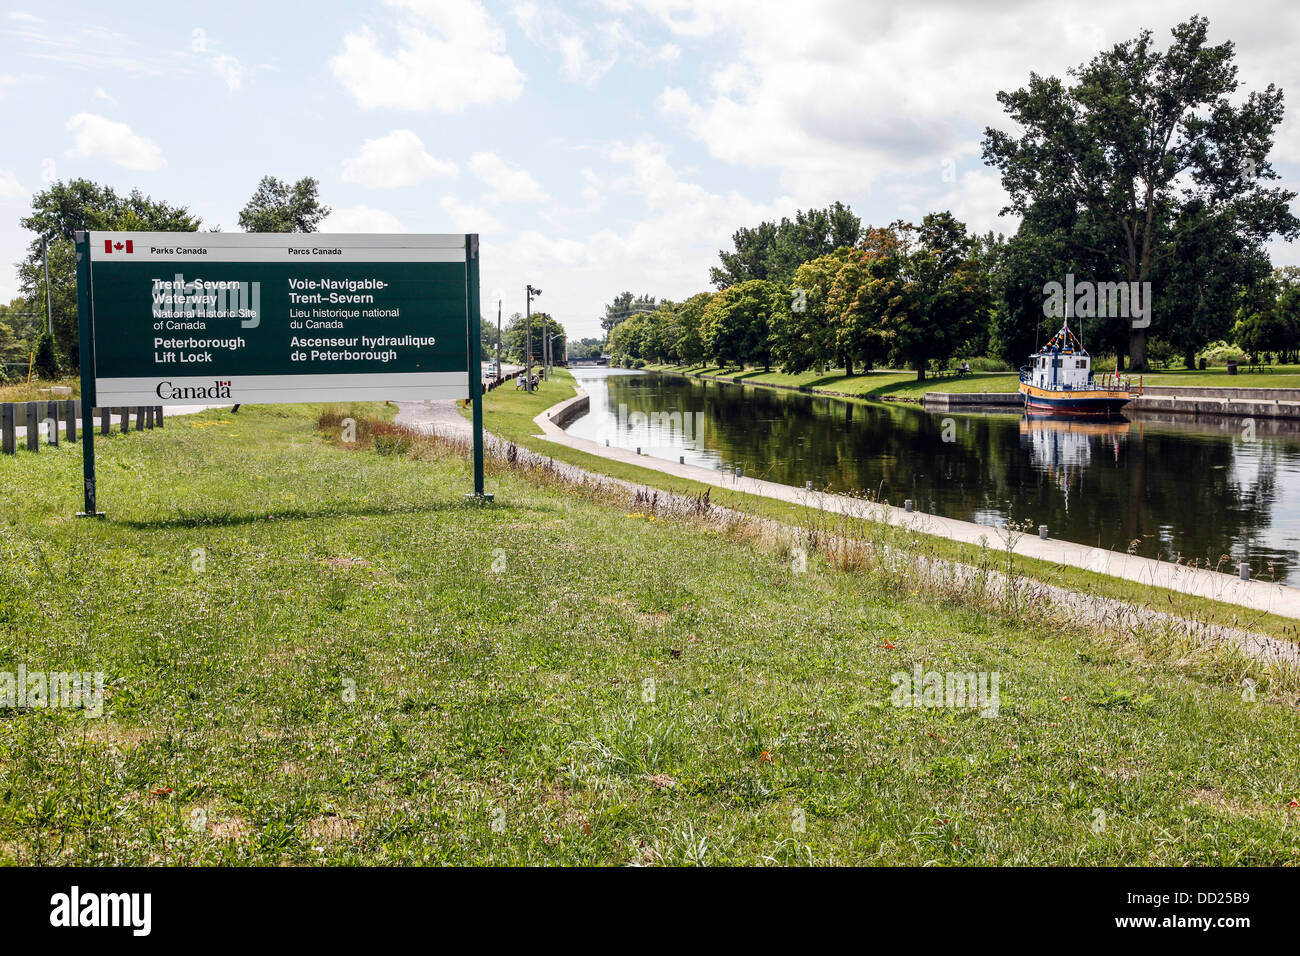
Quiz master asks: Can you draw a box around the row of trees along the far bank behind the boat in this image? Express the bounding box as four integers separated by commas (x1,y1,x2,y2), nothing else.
608,17,1300,377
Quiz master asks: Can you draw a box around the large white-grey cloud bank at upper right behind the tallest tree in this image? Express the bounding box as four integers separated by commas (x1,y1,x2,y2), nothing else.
647,0,1300,204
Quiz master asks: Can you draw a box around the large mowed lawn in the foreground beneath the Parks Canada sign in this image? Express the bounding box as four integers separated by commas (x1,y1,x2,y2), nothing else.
0,400,1300,865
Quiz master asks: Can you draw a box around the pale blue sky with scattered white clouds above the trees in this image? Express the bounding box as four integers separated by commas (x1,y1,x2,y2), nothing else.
0,0,1300,336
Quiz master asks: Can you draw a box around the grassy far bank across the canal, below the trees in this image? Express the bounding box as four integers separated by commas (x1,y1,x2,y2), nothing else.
647,365,1300,402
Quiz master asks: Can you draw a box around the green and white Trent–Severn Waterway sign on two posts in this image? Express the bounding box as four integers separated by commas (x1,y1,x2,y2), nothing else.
77,232,484,515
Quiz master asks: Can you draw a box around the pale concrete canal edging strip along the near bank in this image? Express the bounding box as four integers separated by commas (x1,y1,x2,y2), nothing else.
534,395,1300,618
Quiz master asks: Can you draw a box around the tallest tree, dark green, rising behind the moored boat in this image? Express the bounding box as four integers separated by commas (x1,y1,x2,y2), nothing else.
984,17,1300,369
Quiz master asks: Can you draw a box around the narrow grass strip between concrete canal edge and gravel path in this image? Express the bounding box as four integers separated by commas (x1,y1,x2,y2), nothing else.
464,369,1300,641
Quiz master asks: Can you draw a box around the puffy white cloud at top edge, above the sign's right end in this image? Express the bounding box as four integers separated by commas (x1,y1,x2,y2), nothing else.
330,0,524,113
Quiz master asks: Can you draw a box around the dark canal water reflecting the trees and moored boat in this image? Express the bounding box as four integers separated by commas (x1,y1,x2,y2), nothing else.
568,368,1300,587
